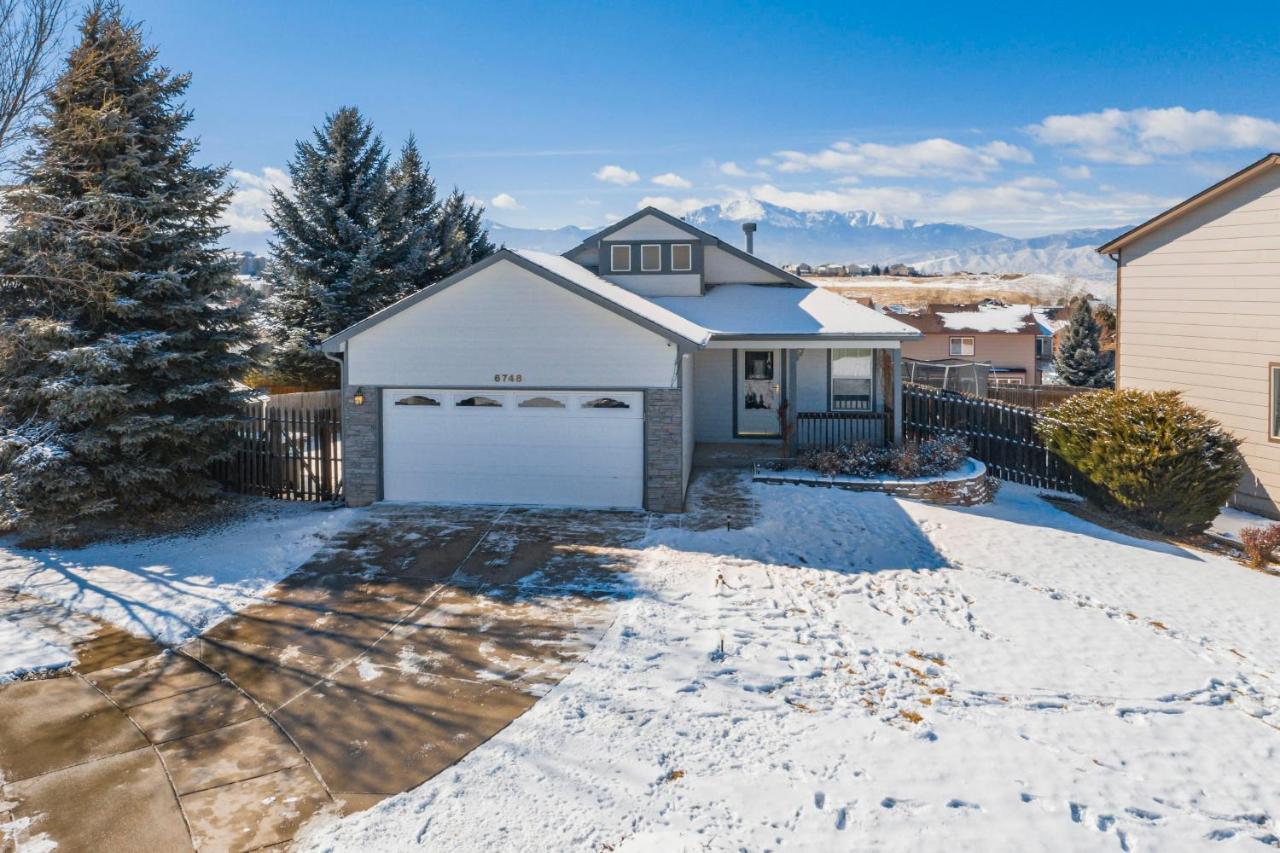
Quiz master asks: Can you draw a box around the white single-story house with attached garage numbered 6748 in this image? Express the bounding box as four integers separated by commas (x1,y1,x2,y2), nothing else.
321,207,918,512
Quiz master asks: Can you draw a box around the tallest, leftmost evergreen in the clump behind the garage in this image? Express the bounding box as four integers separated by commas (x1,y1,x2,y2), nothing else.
257,106,401,387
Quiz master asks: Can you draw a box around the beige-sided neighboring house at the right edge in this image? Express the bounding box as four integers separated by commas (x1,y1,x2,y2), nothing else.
1098,154,1280,517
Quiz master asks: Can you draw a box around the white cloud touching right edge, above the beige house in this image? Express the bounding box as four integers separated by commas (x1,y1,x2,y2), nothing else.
1027,106,1280,165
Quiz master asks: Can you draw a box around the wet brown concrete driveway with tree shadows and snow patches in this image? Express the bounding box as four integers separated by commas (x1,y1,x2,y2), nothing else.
0,506,646,853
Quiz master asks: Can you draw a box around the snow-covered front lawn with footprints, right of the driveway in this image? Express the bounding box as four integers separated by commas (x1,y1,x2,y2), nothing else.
302,485,1280,852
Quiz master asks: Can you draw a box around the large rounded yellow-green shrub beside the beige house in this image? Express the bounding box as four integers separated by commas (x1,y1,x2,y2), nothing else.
1037,391,1244,533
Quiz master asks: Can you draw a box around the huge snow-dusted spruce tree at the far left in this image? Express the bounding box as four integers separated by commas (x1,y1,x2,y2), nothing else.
0,3,252,535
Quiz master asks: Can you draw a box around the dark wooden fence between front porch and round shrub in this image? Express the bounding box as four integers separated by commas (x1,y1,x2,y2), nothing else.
902,384,1084,494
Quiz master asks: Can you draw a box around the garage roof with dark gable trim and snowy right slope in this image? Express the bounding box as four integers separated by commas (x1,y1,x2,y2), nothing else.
320,248,710,352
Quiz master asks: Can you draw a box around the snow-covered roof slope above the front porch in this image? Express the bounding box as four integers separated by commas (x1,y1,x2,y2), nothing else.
653,284,916,338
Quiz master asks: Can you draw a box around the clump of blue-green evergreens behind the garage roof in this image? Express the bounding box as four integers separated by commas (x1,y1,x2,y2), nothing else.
268,114,494,386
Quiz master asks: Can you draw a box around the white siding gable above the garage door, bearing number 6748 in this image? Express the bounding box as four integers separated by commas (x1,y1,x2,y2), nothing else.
347,257,677,388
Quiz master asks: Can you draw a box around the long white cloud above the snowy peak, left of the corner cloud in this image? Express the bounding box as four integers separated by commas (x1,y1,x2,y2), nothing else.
774,138,1033,181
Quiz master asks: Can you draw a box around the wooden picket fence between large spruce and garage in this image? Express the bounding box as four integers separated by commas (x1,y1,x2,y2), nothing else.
214,392,342,501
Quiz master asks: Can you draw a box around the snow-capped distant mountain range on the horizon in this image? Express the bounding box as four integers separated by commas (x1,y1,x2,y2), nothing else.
488,201,1129,278
